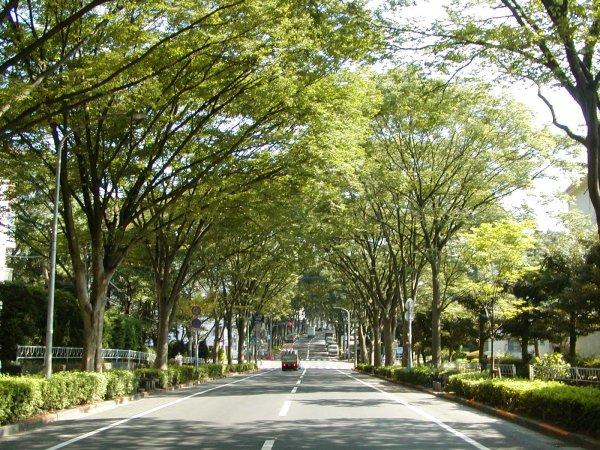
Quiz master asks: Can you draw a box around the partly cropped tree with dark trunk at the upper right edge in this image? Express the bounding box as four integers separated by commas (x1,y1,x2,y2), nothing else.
402,0,600,233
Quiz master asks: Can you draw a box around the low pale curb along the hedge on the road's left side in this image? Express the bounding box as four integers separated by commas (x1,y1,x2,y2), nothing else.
0,370,256,439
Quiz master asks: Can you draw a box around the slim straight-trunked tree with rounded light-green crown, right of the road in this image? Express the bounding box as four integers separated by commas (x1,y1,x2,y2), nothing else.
373,69,547,365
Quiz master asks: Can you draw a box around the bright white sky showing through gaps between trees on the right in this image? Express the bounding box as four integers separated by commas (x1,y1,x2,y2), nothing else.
370,0,585,230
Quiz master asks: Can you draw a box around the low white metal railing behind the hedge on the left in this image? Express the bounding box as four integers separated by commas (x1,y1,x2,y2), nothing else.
17,345,156,364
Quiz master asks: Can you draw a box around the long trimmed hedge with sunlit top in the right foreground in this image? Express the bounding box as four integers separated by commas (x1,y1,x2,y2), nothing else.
448,374,600,435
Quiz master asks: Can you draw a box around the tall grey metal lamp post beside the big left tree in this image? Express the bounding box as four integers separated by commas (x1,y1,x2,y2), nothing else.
44,134,67,378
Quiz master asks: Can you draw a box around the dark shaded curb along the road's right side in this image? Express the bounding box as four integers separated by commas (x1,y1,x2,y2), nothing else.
355,370,600,449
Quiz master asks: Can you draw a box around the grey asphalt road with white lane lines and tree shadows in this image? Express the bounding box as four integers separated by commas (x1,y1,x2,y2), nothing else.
0,332,575,450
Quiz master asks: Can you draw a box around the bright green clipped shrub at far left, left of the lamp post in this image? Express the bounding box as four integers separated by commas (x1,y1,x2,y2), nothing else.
0,376,45,425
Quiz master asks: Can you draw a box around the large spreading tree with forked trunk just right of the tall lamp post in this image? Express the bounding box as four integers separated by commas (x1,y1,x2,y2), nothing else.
5,1,378,370
